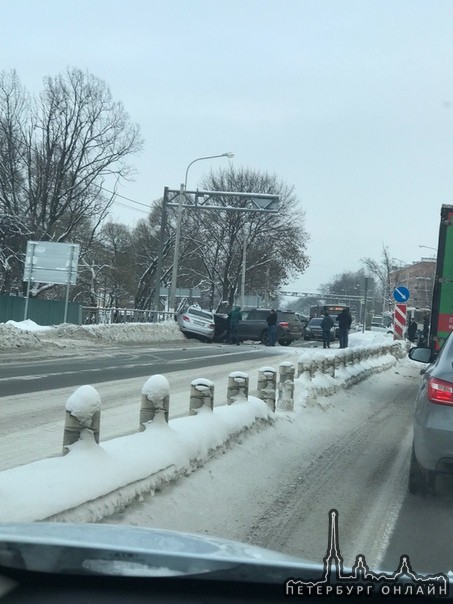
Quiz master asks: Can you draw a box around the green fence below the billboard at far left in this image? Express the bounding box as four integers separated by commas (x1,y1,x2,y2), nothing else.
0,296,82,325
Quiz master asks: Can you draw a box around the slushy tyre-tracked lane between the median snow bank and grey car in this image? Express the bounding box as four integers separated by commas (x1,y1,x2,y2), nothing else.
106,361,419,567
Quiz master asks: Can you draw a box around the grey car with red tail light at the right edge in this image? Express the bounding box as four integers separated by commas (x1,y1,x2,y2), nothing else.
409,333,453,494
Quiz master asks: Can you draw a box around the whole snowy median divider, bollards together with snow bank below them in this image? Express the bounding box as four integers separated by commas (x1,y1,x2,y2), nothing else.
0,342,406,522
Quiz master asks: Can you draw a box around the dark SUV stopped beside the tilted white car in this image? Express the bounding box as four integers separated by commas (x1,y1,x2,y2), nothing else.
239,308,304,346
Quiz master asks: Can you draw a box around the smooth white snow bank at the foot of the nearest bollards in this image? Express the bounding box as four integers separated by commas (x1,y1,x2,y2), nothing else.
0,397,271,522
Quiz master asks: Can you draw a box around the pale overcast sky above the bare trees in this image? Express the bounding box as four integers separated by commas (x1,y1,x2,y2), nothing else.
0,0,453,291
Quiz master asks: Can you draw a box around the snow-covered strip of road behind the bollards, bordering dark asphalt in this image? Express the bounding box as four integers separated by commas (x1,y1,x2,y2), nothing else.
0,348,301,471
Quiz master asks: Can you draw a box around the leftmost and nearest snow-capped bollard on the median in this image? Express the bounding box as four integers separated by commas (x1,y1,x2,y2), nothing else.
63,385,101,455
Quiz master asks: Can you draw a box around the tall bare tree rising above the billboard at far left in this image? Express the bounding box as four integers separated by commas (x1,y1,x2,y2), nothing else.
0,68,142,296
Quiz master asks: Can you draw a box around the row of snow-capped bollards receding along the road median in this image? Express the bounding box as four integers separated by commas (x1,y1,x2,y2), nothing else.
63,342,405,455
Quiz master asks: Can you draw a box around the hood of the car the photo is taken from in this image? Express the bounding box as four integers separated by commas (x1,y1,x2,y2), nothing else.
0,522,321,584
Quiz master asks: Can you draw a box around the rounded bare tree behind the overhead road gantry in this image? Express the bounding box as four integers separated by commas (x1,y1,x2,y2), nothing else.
180,167,308,307
